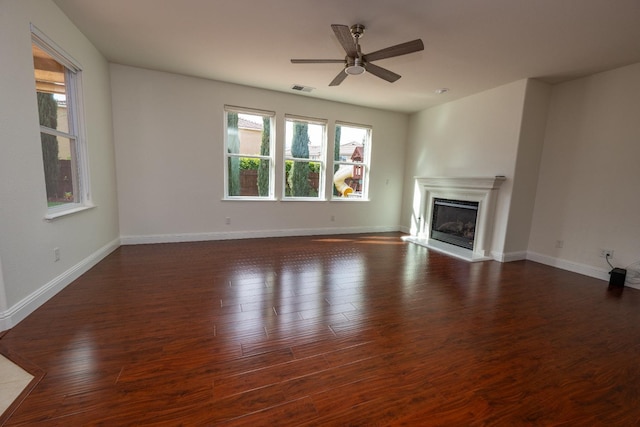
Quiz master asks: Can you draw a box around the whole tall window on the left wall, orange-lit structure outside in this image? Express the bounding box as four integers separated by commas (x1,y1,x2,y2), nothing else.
31,28,89,219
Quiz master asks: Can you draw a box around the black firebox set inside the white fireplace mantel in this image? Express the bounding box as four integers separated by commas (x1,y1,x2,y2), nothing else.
431,198,479,250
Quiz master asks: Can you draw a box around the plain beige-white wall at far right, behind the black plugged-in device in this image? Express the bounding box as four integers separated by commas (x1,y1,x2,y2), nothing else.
529,64,640,287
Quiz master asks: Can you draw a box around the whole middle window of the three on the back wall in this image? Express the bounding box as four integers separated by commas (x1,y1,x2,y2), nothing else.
284,116,327,200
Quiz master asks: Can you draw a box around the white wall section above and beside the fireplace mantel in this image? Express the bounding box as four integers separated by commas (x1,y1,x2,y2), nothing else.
402,80,527,258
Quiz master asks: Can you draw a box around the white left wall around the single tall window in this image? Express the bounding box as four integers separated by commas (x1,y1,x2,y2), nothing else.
0,0,119,330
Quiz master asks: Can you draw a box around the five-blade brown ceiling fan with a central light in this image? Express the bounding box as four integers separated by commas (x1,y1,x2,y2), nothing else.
291,24,424,86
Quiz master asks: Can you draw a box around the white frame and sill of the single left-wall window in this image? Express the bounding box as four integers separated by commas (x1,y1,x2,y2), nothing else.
31,24,95,220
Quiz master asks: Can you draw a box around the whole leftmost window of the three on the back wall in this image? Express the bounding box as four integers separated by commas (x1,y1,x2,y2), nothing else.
225,106,275,199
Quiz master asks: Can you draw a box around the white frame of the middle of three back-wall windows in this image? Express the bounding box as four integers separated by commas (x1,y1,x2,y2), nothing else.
281,114,329,202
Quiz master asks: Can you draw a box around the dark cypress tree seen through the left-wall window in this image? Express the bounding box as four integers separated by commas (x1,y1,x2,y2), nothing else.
37,92,60,200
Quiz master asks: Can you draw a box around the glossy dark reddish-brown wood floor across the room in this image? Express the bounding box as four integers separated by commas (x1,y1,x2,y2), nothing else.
0,233,640,426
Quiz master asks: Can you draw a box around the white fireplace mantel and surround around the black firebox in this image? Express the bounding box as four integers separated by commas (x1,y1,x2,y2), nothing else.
407,176,506,262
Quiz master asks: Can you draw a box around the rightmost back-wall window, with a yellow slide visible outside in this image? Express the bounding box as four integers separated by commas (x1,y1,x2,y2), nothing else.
333,123,371,200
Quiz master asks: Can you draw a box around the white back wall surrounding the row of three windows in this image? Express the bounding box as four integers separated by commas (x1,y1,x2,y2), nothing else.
111,64,408,243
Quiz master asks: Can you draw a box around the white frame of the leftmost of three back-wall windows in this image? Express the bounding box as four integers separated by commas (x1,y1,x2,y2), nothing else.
223,105,276,201
